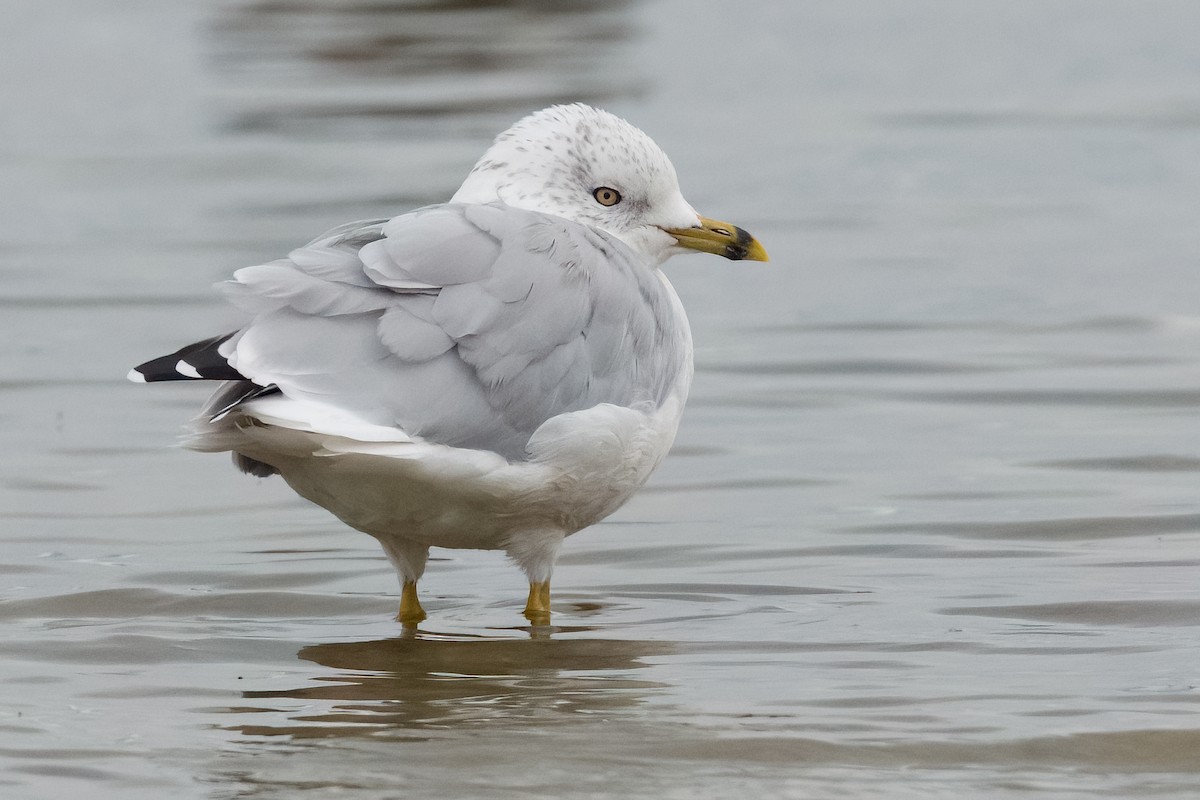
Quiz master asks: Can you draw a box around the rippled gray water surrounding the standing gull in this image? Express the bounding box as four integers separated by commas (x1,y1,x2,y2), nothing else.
0,0,1200,800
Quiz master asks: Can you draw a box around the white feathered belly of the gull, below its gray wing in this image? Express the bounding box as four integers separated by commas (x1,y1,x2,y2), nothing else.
253,381,686,549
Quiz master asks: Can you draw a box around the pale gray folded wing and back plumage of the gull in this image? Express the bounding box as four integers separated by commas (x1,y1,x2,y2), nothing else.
222,204,690,459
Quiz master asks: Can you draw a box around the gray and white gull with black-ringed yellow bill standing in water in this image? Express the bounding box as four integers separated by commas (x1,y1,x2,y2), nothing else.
128,103,767,626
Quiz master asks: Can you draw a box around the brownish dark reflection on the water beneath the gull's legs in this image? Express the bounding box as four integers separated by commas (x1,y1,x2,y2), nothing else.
228,626,677,739
